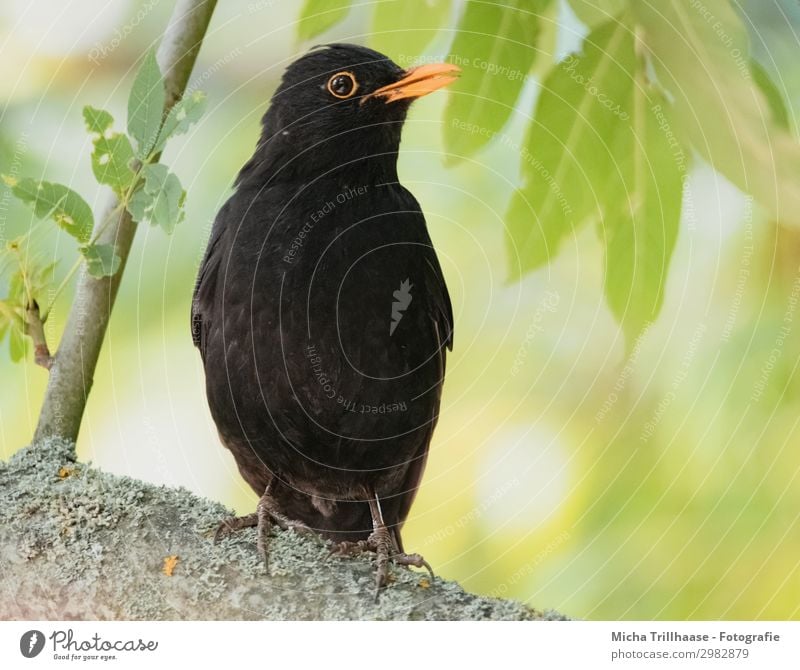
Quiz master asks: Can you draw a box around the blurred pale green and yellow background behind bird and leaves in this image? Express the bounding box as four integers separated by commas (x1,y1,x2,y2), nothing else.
0,0,800,619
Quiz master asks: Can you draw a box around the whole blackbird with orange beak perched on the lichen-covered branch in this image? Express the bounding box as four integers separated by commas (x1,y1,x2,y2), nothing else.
192,44,458,590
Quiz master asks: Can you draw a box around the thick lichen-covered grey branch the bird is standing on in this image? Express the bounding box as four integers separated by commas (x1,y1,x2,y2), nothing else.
0,439,564,620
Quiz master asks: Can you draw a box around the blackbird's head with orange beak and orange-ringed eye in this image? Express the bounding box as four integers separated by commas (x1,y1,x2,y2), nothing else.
234,44,460,182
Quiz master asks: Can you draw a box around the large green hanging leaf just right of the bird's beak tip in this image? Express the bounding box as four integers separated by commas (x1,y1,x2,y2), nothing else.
444,0,550,161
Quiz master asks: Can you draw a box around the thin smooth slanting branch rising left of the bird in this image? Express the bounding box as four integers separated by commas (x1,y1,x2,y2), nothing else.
34,0,217,448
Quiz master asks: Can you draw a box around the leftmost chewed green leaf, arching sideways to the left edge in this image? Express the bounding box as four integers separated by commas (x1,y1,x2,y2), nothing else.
3,175,94,242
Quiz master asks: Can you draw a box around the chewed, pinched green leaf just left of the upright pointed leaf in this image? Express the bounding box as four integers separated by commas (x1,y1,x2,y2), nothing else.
83,106,136,198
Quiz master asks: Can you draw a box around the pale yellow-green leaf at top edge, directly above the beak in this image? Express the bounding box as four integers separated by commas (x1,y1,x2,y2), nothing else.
370,0,450,61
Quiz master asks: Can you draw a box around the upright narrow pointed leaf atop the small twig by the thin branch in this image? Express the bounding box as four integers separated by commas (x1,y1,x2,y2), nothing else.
128,49,166,160
